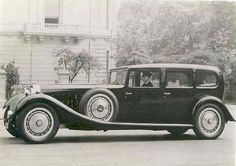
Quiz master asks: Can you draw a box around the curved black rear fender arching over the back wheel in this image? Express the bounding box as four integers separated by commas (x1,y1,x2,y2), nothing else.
192,96,235,121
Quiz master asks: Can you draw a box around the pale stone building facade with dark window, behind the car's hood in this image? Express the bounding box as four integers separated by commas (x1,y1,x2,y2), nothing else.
0,0,116,89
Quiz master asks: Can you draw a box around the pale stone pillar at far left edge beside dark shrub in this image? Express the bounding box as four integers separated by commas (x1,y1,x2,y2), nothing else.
0,69,6,107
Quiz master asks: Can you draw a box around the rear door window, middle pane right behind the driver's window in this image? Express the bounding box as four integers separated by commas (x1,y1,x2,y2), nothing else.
166,70,193,88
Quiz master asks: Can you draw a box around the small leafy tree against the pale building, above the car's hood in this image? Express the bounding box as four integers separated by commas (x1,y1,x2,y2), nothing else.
54,48,98,83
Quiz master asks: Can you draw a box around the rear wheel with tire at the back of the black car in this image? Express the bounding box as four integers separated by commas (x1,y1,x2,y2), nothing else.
193,104,225,139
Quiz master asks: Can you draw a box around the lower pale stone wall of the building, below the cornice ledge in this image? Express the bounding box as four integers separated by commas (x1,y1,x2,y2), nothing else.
0,34,110,84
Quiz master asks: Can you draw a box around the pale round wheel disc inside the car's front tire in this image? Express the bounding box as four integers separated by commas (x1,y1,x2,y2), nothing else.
24,108,54,141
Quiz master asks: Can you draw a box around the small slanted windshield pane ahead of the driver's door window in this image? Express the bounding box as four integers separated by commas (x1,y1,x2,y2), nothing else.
110,69,127,85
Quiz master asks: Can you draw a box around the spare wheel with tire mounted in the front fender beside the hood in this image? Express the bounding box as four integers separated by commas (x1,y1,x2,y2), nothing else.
79,88,119,122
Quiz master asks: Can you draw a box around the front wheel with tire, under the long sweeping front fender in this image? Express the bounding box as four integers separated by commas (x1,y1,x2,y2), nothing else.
16,103,59,144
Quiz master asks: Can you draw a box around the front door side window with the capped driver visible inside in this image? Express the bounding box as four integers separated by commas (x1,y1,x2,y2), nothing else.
129,70,161,88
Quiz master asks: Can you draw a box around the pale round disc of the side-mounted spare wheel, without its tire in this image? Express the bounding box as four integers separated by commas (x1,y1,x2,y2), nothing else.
87,94,114,121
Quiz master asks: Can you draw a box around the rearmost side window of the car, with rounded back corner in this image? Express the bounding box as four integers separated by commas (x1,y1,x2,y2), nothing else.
196,70,217,87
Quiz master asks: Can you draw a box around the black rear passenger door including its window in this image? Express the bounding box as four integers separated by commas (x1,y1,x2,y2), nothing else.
162,68,194,123
